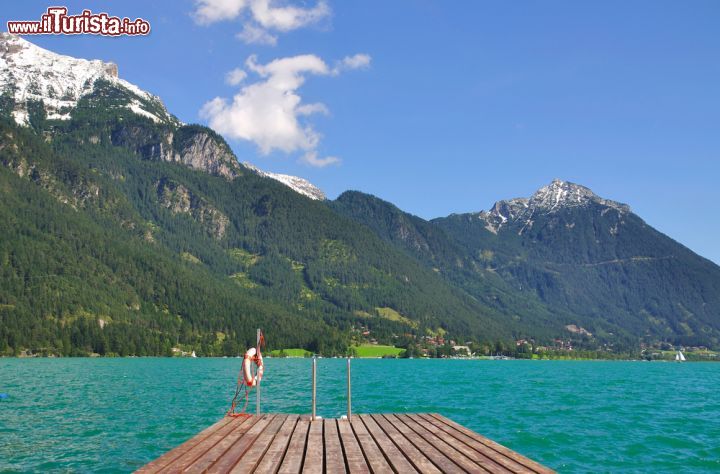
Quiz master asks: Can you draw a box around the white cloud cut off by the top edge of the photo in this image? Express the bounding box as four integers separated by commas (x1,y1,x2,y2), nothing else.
193,0,330,45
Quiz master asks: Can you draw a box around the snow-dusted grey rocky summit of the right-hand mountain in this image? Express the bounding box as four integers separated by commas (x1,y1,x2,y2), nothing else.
477,179,630,234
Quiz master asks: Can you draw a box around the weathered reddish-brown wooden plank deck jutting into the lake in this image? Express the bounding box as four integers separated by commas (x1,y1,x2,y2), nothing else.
138,414,553,474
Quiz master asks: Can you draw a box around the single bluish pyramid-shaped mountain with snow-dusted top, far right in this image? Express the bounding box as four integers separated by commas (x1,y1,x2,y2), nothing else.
433,180,720,345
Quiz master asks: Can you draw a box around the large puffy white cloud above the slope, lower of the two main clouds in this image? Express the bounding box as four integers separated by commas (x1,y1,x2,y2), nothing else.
200,54,370,167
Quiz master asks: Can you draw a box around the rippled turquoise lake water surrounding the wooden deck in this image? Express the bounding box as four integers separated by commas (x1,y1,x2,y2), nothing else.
0,359,720,473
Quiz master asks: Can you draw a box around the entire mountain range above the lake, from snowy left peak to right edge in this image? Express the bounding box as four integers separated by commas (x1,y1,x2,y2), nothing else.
0,34,720,355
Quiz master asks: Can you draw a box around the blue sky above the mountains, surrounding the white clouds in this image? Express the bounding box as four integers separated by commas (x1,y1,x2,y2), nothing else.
0,0,720,262
